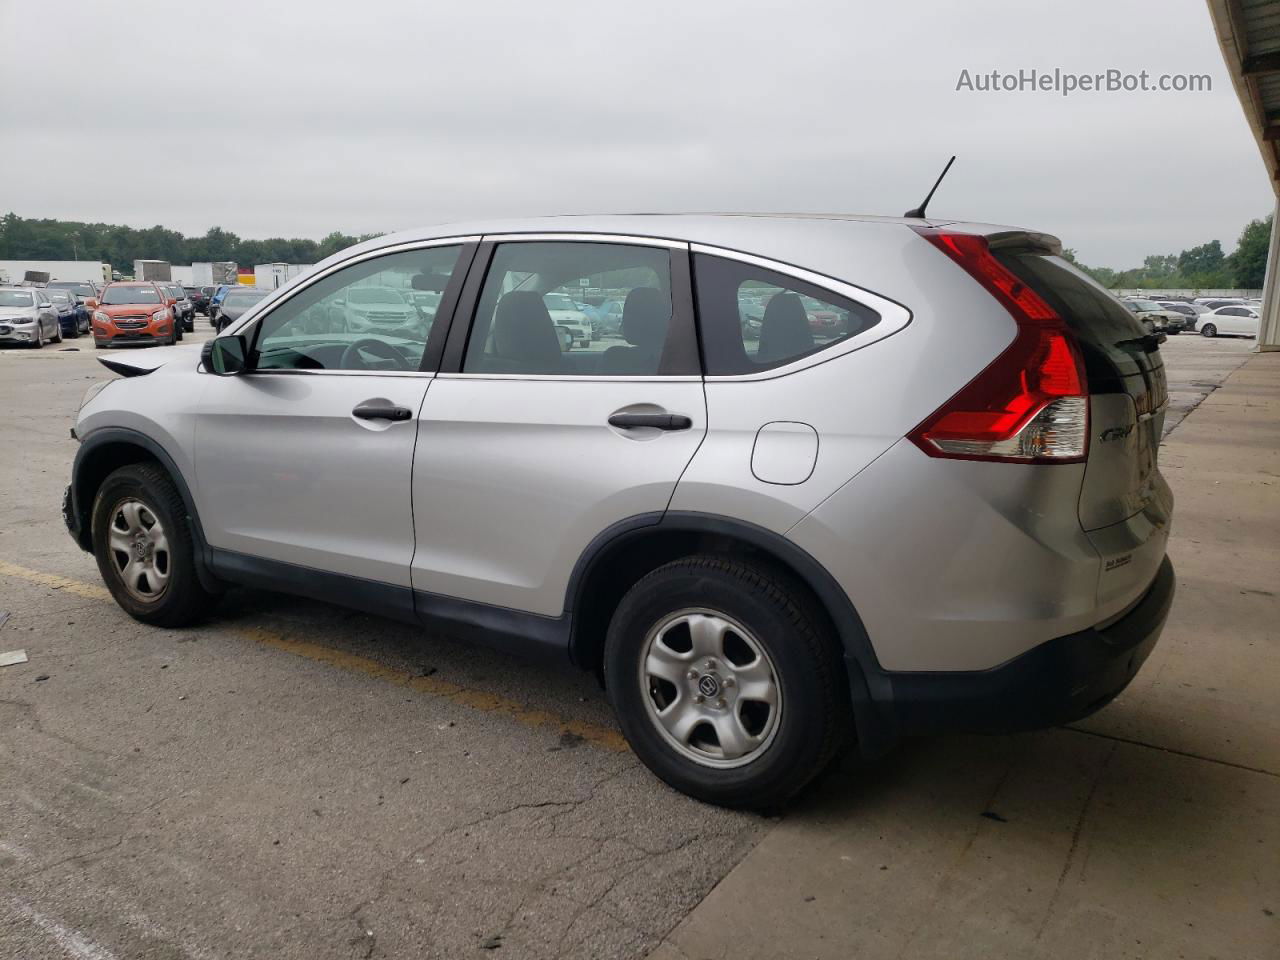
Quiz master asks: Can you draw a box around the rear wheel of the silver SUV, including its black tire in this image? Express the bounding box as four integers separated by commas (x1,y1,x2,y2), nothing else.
604,556,854,810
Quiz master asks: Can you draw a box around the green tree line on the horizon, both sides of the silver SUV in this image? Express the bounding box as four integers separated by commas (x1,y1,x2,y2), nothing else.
0,212,1271,289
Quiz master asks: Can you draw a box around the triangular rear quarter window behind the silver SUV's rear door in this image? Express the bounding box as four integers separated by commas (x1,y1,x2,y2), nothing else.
694,253,881,376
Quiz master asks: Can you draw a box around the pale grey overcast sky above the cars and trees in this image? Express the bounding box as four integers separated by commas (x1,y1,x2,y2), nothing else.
0,0,1272,268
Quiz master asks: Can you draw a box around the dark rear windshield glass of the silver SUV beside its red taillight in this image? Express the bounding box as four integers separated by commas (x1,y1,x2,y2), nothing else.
992,250,1161,390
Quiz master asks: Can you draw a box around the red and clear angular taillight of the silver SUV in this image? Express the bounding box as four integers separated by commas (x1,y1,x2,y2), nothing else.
909,228,1089,463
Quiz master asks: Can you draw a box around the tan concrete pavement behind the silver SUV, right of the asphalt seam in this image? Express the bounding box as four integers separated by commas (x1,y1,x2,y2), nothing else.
652,353,1280,960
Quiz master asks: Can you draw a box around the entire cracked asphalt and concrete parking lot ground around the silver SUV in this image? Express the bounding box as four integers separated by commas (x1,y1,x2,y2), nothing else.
0,327,1280,960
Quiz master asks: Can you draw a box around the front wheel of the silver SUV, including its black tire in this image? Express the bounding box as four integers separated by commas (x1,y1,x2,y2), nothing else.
91,463,218,627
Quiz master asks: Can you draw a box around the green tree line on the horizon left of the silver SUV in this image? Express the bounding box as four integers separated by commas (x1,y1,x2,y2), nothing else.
0,212,379,271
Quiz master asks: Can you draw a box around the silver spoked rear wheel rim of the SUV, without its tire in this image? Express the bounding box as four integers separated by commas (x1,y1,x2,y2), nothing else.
637,609,782,769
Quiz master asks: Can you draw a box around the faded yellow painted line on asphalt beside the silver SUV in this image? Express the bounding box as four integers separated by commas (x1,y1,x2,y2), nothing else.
0,561,630,753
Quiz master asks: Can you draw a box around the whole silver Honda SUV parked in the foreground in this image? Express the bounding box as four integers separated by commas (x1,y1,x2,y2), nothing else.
65,216,1174,808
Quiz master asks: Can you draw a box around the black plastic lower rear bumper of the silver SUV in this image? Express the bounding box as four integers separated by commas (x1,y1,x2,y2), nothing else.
865,557,1175,740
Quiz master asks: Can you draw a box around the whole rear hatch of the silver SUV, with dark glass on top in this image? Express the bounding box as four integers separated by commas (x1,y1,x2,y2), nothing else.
988,244,1172,611
